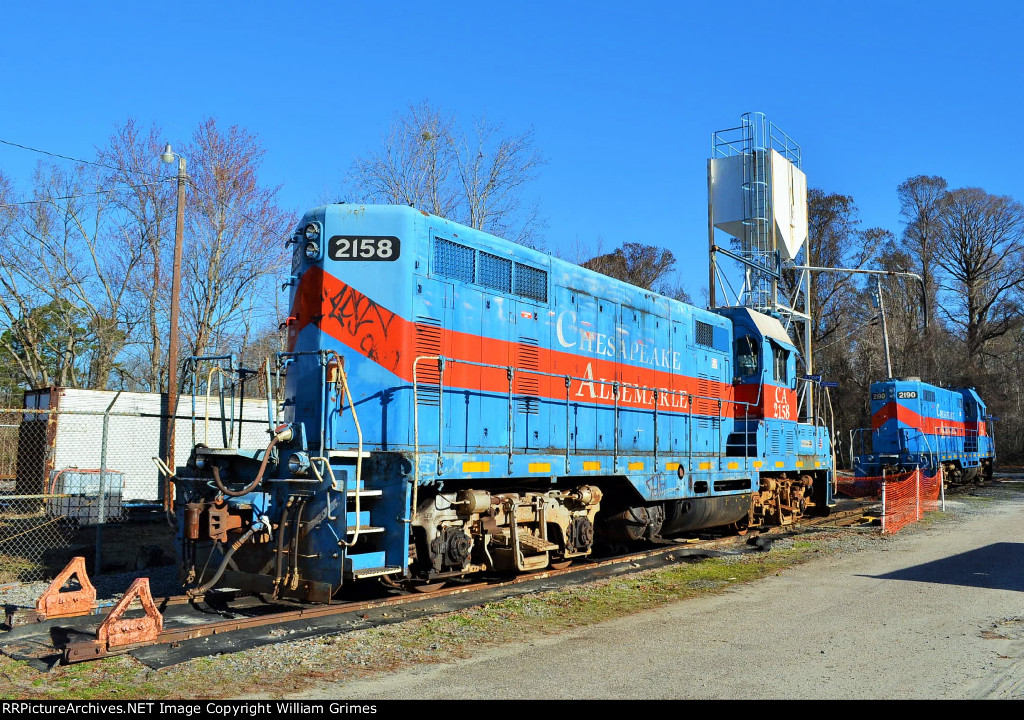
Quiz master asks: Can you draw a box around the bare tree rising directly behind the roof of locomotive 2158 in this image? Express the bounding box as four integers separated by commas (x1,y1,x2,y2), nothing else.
349,101,545,244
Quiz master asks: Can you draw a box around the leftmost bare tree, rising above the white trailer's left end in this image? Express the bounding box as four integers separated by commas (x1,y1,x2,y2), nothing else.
0,165,147,388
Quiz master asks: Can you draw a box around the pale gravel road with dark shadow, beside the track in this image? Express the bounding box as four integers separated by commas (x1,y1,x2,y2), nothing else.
293,478,1024,700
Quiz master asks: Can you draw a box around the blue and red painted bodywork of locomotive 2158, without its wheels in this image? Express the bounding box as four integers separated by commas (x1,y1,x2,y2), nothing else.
287,205,830,573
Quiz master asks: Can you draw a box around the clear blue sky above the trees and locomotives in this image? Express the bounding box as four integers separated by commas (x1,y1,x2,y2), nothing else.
0,0,1024,299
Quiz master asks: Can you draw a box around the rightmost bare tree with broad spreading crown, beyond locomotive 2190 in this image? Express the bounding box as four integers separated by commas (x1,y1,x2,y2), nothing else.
935,187,1024,367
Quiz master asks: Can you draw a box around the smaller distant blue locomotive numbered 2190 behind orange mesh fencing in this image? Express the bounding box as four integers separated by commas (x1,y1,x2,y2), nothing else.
854,378,995,482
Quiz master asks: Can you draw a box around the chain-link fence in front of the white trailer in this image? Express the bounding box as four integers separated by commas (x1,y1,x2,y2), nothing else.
0,388,268,584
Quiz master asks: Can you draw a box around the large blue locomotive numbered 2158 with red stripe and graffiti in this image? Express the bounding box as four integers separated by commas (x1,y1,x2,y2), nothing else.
176,204,833,601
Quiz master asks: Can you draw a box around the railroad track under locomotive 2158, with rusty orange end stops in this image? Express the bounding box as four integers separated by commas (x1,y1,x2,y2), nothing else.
0,505,863,667
